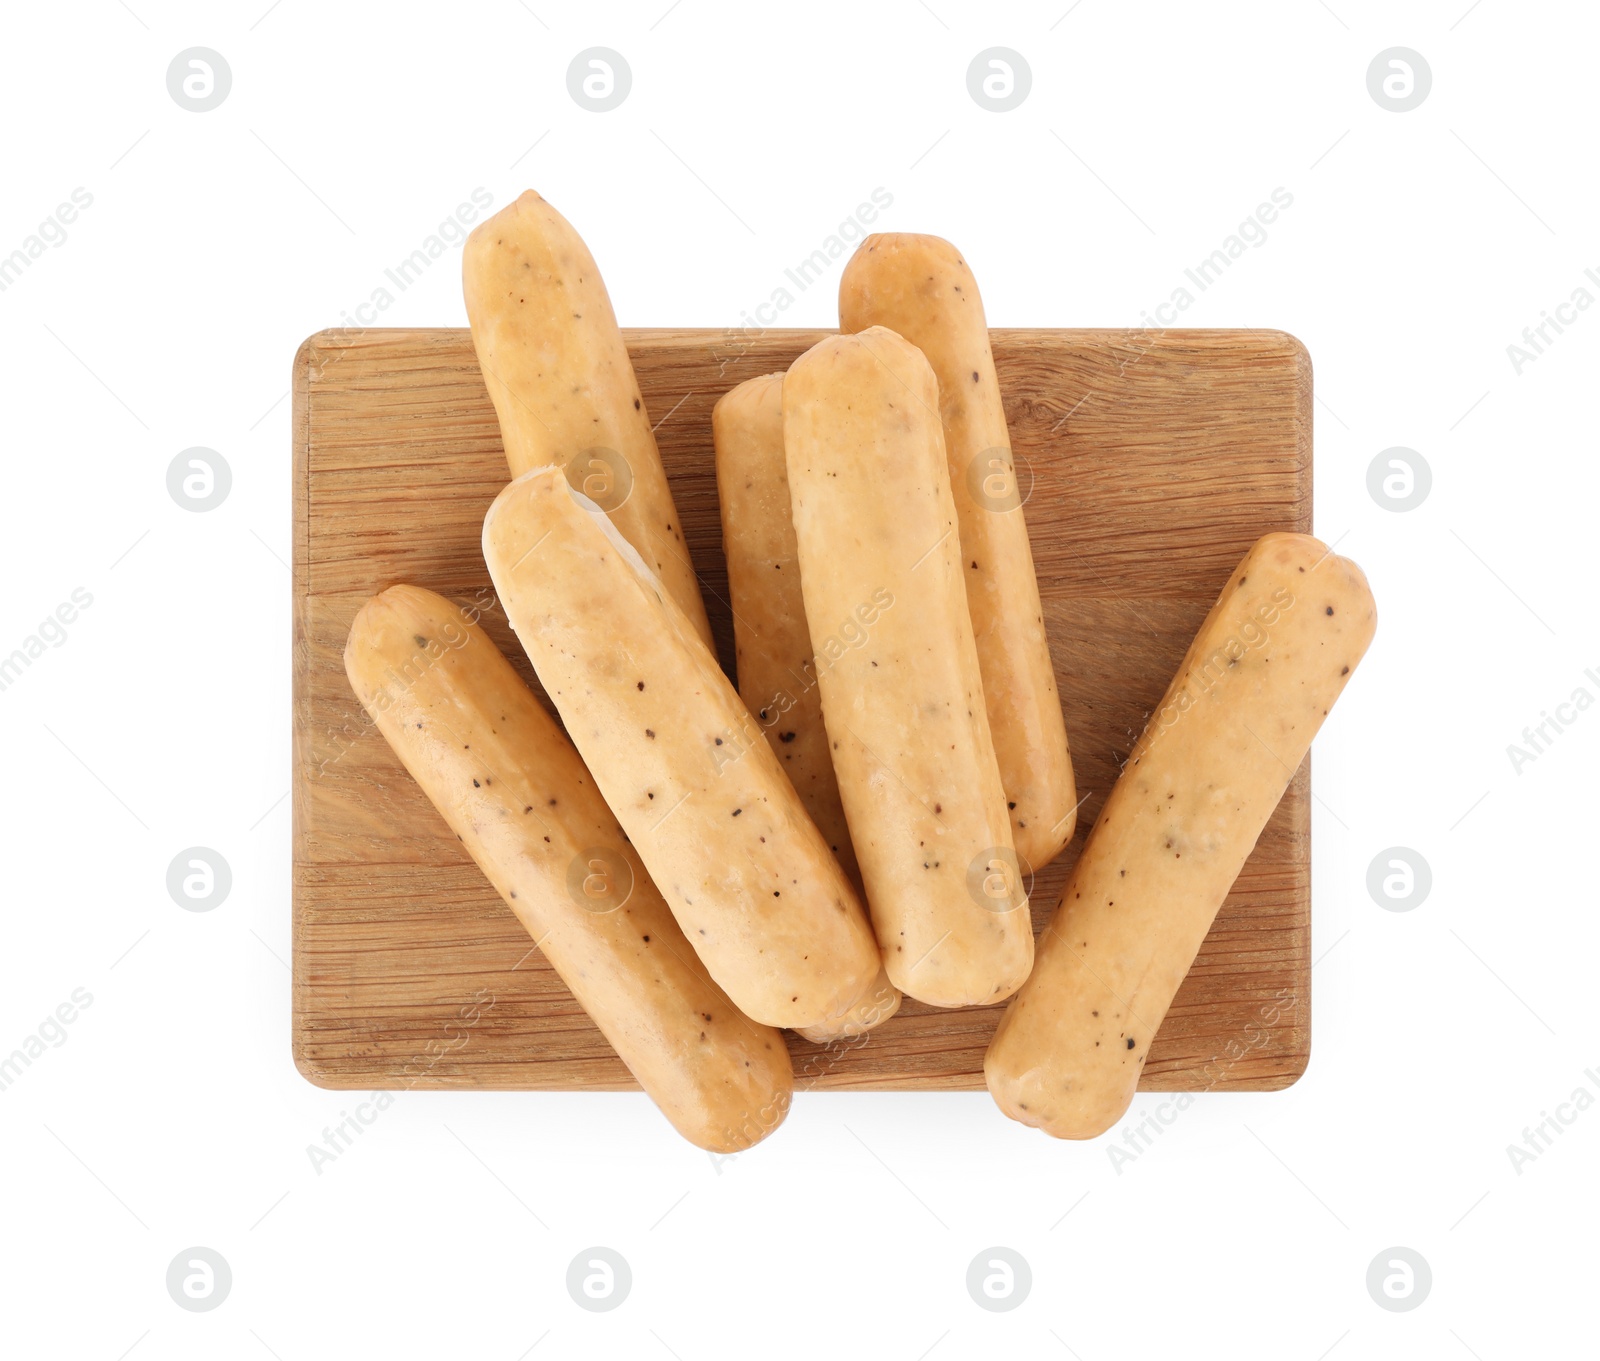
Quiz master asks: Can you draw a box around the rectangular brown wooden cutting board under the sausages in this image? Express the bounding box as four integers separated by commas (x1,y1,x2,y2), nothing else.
293,329,1312,1091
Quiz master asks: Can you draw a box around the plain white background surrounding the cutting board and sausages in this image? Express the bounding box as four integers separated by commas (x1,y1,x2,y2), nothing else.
0,0,1600,1361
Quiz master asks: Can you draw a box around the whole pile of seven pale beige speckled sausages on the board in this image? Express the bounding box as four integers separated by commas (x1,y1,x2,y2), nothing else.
346,192,1374,1151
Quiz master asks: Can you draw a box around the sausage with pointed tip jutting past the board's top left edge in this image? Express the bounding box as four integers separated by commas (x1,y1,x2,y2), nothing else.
461,189,714,646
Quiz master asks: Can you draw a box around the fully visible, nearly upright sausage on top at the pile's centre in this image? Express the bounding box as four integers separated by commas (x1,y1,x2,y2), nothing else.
782,326,1034,1006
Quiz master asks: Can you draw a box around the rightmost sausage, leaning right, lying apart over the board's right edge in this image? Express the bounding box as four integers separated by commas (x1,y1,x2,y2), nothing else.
984,534,1378,1139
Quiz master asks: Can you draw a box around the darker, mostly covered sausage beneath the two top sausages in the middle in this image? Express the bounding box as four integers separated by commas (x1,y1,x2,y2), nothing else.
710,373,901,1044
